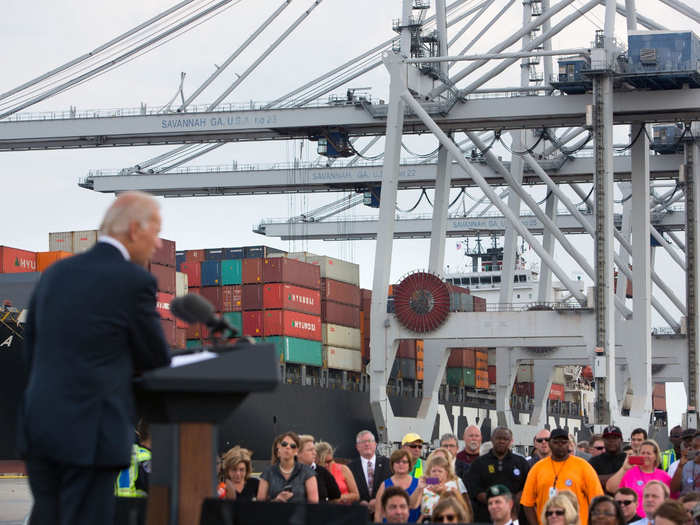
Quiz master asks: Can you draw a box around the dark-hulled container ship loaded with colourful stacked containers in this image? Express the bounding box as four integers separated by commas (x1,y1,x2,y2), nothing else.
0,235,665,459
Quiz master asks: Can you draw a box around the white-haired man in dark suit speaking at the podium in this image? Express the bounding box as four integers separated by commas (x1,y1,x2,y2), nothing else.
19,192,170,525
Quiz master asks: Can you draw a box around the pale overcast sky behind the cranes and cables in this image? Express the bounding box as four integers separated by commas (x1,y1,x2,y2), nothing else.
0,0,700,426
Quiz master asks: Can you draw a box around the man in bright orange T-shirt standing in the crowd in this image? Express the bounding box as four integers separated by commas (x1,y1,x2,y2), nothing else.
520,428,603,525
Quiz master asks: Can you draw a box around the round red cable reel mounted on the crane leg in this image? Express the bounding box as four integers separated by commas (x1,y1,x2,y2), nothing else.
394,272,450,333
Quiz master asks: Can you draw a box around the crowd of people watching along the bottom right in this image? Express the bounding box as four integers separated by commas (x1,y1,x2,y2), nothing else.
206,426,700,525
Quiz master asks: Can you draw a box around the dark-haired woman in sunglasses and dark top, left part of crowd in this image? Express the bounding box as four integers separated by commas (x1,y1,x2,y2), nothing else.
257,432,318,503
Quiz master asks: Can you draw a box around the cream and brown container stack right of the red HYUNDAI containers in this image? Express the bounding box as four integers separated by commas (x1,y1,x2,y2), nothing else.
287,252,360,370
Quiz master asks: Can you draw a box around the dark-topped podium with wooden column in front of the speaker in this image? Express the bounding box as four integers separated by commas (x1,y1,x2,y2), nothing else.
134,343,280,525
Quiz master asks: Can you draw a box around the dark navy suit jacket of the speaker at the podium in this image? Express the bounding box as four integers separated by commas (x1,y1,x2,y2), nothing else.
18,243,170,468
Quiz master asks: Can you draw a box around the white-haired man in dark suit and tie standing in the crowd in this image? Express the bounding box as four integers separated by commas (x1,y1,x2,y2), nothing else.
348,430,391,514
